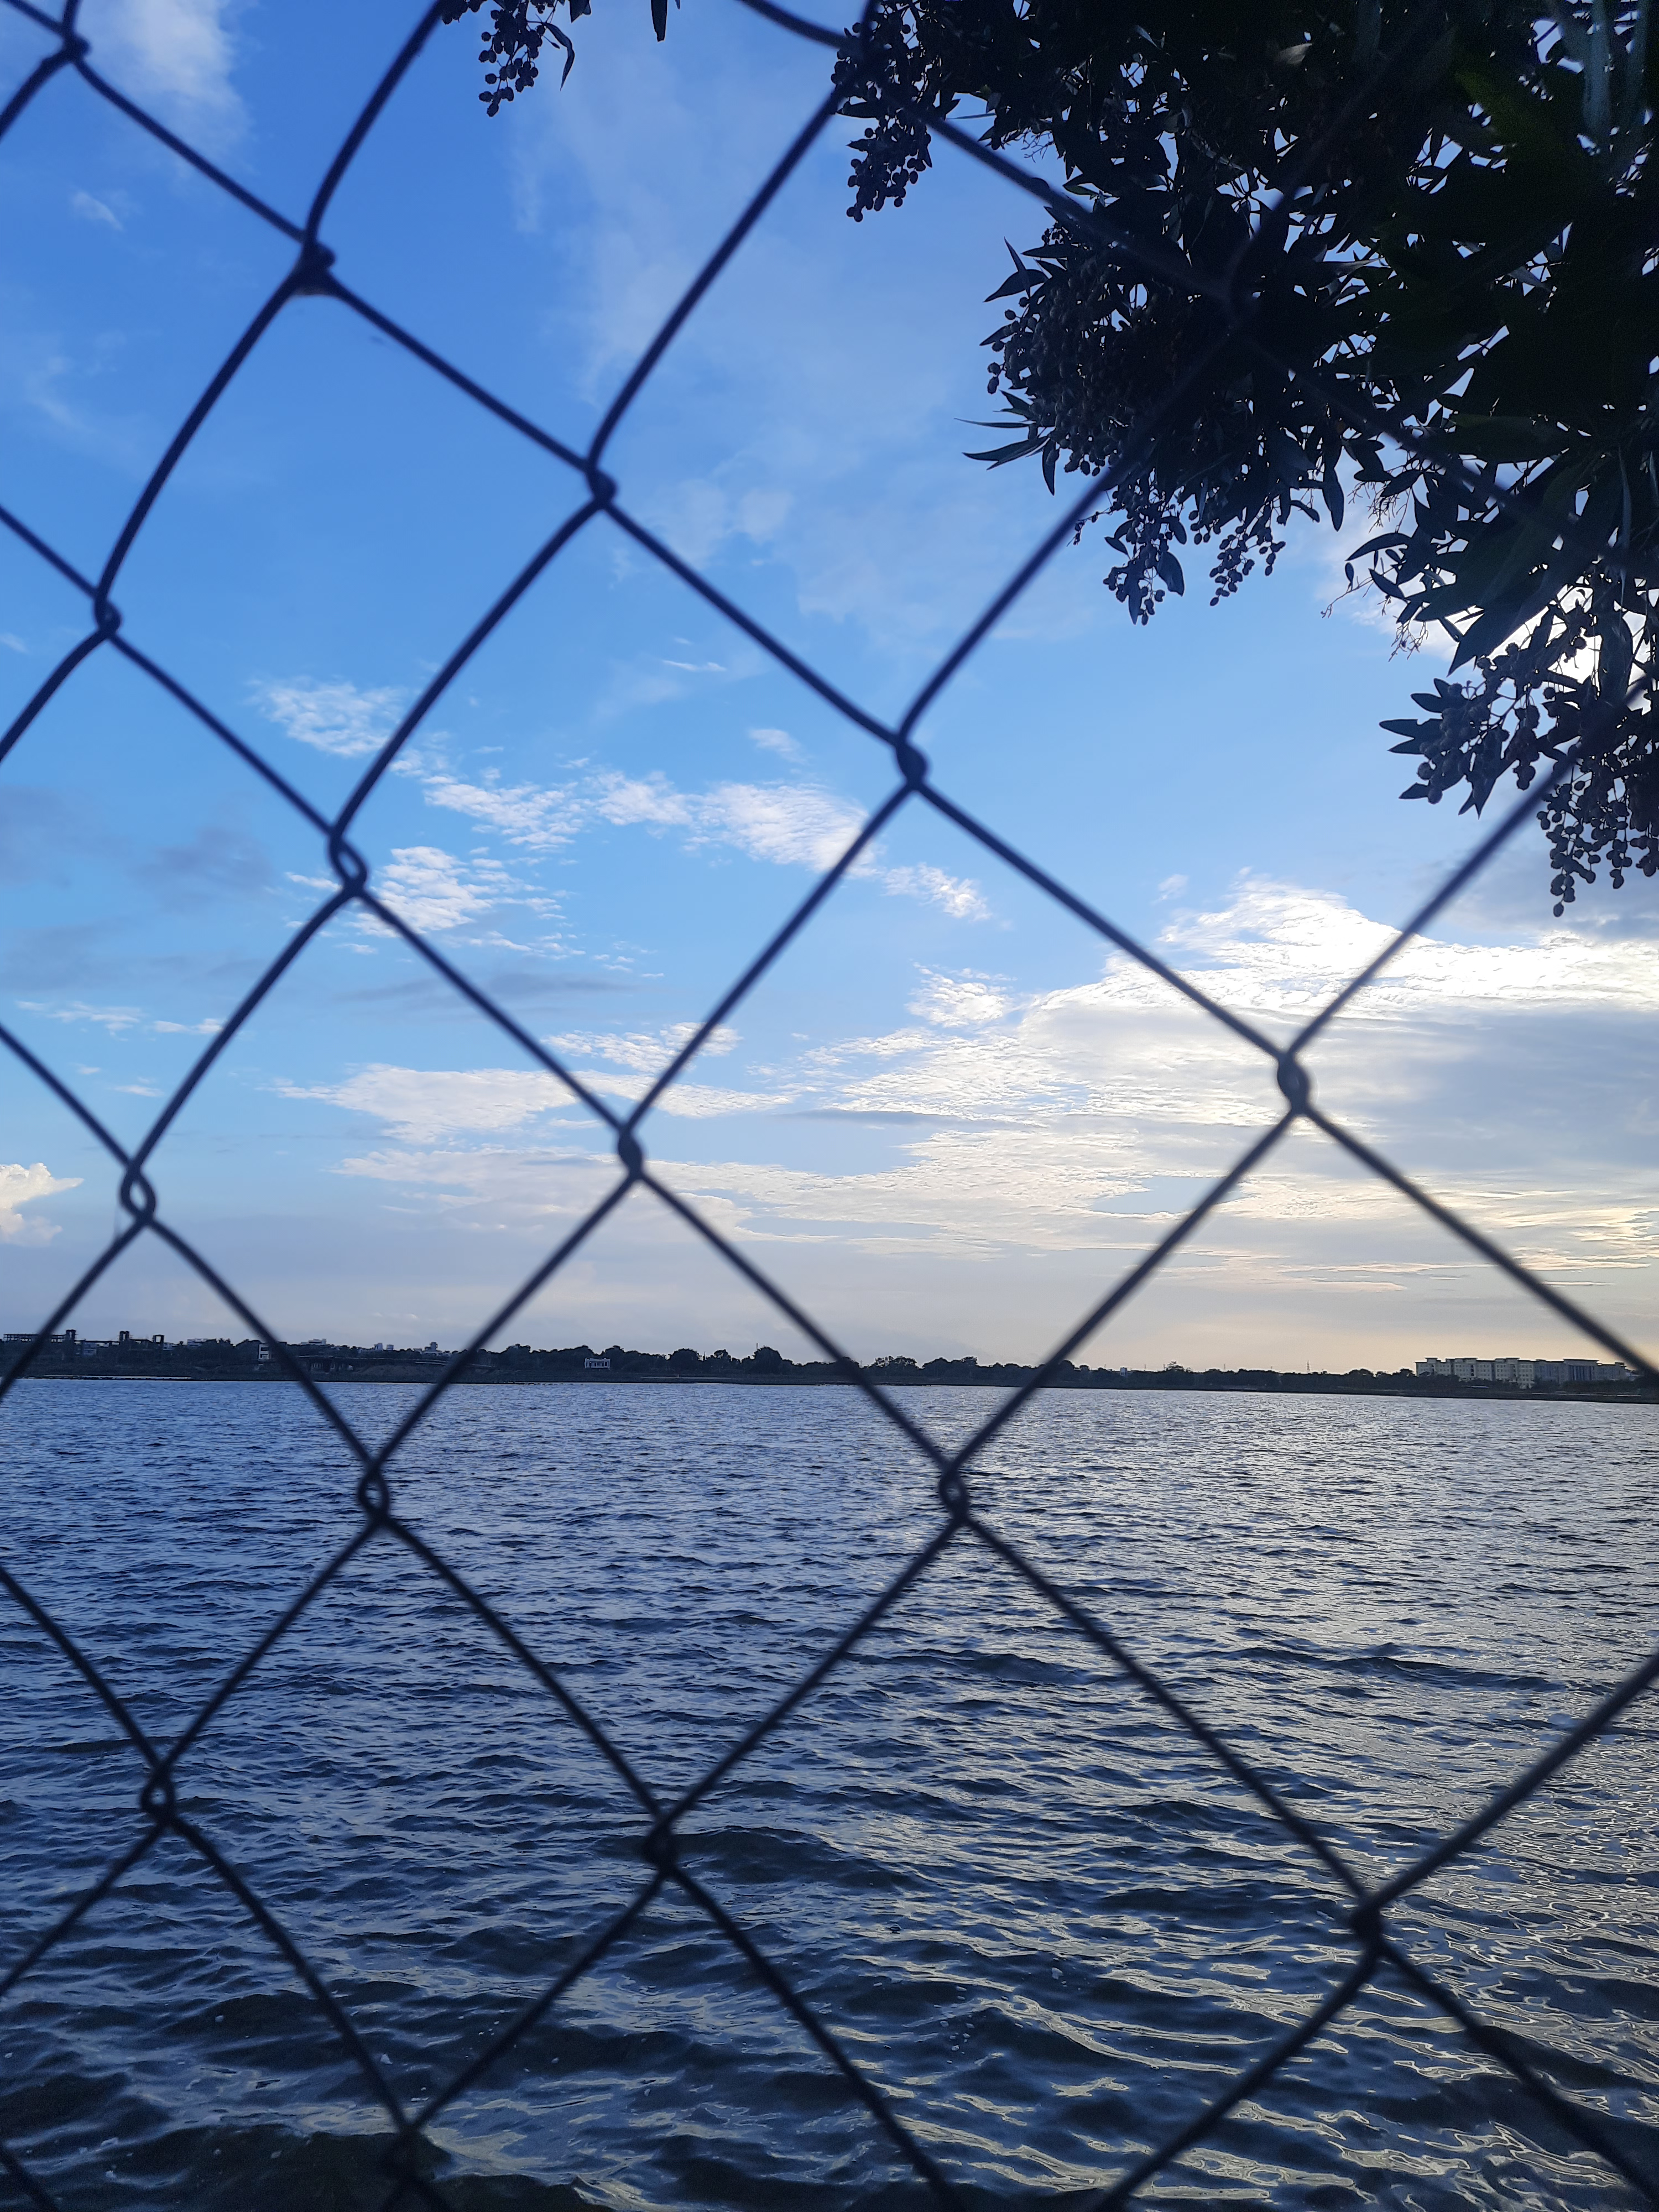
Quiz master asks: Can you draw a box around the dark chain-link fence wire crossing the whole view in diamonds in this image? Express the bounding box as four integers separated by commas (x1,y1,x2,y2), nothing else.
0,0,1659,2212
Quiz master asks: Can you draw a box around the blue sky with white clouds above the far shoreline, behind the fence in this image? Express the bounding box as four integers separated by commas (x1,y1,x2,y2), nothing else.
0,0,1659,1367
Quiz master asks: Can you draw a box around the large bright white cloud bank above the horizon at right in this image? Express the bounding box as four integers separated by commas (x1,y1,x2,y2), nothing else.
292,878,1659,1365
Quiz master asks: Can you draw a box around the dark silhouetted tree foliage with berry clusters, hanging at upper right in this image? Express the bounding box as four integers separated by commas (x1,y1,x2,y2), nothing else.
456,0,1659,914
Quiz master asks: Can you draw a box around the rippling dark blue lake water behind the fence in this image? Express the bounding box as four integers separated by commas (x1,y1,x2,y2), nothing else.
0,1383,1659,2212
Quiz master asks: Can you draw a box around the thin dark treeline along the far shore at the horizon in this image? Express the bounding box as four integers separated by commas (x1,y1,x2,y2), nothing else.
0,1332,1659,1402
